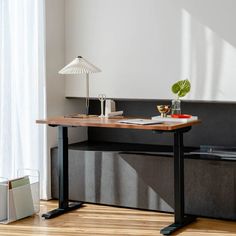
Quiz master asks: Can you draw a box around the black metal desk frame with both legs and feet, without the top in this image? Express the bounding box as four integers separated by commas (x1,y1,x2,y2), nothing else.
42,125,196,235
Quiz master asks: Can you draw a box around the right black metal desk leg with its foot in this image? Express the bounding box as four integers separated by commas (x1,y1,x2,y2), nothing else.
161,131,195,235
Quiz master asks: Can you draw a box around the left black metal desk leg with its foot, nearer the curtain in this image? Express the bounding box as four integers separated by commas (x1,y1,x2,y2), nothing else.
42,126,83,219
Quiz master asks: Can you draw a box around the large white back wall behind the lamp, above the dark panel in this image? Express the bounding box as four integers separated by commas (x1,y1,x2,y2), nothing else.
65,0,236,101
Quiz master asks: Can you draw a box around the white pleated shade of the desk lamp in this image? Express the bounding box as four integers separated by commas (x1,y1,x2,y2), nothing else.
58,56,101,75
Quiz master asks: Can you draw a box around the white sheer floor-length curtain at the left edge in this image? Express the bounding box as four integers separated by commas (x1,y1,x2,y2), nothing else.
0,0,47,198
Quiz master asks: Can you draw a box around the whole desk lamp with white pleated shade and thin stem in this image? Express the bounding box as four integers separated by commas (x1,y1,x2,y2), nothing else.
58,56,101,117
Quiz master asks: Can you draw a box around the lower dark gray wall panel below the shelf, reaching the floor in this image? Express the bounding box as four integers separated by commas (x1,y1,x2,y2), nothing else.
52,149,236,219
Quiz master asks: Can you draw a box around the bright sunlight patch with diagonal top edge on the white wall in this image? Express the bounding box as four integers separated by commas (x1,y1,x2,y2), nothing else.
180,10,236,101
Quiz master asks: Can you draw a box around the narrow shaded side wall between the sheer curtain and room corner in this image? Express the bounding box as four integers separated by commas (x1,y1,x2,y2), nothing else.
45,0,87,198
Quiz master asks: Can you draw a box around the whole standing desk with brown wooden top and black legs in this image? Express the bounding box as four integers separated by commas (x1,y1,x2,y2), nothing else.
36,117,200,235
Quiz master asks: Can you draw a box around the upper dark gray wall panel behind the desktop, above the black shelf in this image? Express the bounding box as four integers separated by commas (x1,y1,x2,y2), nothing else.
88,100,236,147
